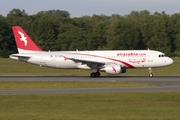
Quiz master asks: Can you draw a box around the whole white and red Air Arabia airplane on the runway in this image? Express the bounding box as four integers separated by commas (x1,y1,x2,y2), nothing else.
9,26,173,78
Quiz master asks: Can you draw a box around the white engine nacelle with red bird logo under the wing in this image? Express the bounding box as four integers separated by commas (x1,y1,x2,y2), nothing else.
104,65,122,74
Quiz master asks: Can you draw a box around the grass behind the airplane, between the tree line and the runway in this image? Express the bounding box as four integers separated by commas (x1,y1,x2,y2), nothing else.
0,58,180,75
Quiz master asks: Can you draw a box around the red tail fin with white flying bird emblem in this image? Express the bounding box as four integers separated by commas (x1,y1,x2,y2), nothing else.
12,26,42,53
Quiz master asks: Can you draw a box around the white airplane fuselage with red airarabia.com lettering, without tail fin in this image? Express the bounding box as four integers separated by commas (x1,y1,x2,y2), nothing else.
10,50,173,70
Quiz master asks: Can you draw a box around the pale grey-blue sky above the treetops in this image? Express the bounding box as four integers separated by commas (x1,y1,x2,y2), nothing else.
0,0,180,18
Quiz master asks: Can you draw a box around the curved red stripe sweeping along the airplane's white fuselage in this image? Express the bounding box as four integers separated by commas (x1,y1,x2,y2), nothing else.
60,52,135,68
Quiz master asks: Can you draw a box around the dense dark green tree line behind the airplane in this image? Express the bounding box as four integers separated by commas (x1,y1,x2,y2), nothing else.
0,9,180,57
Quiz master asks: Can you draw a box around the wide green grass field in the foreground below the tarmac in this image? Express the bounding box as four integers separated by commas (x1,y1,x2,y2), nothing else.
0,92,180,120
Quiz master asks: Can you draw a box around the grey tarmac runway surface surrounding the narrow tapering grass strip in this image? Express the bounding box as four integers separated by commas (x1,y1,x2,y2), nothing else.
0,76,180,94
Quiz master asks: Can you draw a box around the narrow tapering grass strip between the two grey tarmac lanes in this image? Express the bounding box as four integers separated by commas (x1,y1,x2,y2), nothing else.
0,82,155,90
